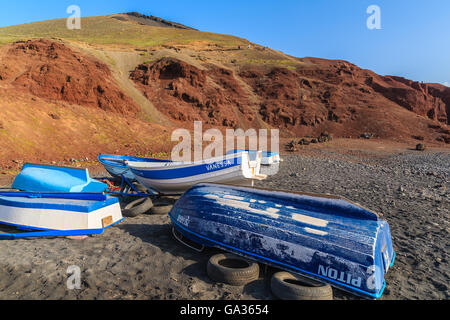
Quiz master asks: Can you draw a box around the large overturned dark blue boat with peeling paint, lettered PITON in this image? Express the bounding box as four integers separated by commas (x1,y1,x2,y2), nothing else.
169,184,395,299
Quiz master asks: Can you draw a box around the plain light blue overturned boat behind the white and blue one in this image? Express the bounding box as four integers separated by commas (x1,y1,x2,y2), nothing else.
12,163,108,193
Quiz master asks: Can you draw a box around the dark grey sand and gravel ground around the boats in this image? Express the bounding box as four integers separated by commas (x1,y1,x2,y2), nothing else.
0,141,450,300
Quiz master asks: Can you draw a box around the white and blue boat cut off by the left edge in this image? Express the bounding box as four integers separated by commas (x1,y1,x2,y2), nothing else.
0,192,123,239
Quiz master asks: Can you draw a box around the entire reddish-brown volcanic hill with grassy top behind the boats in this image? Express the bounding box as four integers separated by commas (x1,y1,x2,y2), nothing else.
0,13,450,168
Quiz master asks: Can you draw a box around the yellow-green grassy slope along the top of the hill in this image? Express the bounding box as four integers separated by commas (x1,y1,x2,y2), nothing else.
0,15,248,47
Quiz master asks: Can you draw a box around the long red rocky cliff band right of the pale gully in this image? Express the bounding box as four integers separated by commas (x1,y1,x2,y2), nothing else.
131,58,450,143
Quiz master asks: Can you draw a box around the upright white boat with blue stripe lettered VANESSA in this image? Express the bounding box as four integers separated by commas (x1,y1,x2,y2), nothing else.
126,152,267,194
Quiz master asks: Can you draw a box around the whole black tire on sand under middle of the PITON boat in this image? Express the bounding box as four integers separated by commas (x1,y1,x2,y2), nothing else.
207,253,259,286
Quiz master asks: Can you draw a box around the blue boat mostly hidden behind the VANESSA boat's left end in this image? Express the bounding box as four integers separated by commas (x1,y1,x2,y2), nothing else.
98,154,170,181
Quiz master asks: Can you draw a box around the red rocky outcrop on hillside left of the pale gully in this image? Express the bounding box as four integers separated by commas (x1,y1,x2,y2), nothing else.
0,39,139,114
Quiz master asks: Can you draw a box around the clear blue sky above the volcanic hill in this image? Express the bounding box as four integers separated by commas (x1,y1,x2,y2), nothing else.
0,0,450,84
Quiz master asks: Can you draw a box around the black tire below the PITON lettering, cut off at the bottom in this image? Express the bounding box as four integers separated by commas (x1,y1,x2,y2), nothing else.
270,272,333,300
